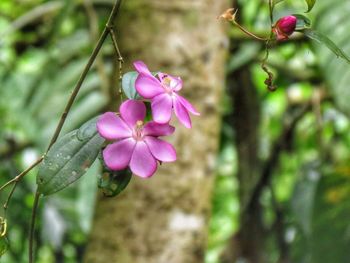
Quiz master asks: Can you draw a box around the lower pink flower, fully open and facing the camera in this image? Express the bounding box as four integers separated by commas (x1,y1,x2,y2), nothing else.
97,100,176,178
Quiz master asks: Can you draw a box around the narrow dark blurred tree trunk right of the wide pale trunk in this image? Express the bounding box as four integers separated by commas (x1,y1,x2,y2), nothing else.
222,67,265,263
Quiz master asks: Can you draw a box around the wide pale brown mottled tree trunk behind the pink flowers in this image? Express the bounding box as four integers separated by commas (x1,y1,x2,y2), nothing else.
84,0,226,263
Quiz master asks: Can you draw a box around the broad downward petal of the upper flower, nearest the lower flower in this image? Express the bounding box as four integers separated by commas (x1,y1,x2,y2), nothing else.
151,93,173,123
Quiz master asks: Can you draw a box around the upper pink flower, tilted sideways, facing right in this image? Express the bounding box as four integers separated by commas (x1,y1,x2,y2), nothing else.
134,61,200,128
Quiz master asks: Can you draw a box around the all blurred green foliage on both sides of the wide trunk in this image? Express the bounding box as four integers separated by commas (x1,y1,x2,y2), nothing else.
0,0,350,263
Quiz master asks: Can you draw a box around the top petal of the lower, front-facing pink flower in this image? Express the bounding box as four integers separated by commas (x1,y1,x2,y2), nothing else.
119,100,146,128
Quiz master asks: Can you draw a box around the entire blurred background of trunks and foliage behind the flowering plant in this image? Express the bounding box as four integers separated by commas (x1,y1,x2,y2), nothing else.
0,0,350,263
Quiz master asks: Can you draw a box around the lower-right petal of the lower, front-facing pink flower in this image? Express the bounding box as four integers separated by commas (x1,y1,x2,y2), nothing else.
145,136,176,162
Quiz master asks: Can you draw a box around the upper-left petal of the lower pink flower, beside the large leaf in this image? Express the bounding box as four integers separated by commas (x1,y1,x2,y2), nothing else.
96,112,132,140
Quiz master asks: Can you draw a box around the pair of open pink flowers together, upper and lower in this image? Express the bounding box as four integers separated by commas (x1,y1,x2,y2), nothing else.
97,61,199,178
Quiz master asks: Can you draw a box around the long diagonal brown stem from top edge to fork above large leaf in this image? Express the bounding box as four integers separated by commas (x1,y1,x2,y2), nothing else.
47,0,122,151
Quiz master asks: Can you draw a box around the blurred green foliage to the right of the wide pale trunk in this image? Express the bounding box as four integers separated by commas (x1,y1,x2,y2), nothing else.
206,0,350,263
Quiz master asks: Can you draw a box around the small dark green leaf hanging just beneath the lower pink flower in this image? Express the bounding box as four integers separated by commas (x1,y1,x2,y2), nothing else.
98,169,132,197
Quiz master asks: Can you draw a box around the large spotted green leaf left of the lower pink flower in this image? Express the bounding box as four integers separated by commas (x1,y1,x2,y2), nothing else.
37,118,104,195
